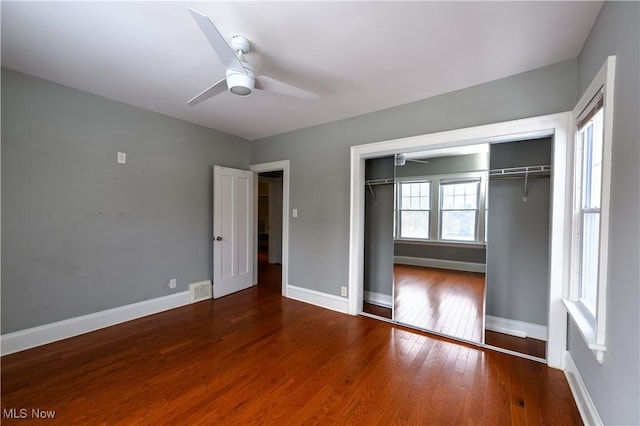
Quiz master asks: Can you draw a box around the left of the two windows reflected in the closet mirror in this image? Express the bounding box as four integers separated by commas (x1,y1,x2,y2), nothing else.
398,181,431,239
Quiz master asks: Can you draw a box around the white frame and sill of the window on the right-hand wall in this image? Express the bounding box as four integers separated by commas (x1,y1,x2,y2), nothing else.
563,56,616,363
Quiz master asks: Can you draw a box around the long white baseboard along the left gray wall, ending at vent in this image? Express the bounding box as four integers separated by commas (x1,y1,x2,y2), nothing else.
0,291,189,355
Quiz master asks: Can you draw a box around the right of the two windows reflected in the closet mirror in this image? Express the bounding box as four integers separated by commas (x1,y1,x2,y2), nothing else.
440,179,480,241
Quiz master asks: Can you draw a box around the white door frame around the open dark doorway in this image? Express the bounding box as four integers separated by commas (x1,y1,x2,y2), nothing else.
249,160,290,297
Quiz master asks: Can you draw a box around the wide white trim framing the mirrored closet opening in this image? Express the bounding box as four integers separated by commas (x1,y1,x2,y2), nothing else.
348,112,573,369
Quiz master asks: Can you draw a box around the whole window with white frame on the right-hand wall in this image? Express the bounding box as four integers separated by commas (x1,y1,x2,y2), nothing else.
563,56,615,363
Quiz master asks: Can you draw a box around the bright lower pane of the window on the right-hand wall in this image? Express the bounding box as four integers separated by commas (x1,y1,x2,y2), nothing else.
579,213,600,315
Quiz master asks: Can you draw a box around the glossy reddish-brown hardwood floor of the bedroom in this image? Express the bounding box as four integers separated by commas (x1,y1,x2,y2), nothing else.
1,265,581,425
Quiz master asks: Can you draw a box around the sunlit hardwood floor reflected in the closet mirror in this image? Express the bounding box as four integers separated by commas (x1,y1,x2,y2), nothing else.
393,264,485,343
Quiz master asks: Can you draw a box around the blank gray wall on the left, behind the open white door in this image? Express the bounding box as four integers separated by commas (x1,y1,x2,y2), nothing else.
2,69,250,334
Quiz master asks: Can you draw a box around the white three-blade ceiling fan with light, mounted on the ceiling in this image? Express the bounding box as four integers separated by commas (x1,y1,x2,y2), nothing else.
187,9,318,106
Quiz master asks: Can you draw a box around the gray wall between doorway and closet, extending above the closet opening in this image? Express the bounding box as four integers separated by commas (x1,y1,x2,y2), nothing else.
251,60,577,295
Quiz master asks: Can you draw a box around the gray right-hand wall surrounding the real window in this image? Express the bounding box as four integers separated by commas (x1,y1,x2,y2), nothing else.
569,2,640,425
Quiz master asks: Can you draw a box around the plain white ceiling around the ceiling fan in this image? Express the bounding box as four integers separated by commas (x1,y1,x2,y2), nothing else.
1,1,602,140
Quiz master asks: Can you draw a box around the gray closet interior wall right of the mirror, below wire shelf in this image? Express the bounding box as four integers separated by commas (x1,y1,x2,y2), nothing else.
486,138,551,325
